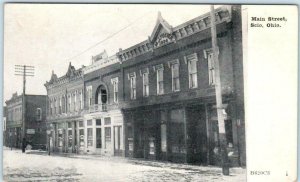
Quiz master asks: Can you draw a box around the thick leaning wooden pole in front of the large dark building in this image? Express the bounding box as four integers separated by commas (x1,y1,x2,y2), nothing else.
210,5,229,175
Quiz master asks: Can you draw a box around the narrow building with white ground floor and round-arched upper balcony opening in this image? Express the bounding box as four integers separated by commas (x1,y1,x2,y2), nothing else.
81,51,124,156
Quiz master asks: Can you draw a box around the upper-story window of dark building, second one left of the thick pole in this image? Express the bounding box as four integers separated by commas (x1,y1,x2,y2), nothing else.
185,53,198,88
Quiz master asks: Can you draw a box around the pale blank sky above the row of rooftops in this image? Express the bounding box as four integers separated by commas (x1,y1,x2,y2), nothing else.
3,4,218,101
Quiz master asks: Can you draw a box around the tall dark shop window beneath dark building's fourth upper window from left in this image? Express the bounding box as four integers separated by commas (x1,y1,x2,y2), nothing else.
170,109,186,153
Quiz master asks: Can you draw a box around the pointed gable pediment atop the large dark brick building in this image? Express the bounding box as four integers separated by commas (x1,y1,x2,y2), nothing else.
149,12,175,48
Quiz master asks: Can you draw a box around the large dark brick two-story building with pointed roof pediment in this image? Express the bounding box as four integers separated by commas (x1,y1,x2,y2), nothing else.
116,6,246,165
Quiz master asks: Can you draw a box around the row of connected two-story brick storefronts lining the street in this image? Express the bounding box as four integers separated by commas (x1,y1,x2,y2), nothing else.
45,6,246,166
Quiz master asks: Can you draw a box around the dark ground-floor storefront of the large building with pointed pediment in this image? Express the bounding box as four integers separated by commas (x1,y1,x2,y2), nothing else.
124,99,238,166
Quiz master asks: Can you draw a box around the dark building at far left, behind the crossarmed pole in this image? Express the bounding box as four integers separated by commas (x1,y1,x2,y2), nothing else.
4,93,46,149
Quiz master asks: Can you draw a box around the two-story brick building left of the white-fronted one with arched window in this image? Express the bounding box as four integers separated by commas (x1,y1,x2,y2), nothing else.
45,63,85,153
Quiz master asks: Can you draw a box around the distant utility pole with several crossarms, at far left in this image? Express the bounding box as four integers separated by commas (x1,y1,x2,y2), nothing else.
15,65,34,140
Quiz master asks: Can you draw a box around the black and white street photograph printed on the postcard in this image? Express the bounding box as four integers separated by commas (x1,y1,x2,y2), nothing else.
2,3,296,182
